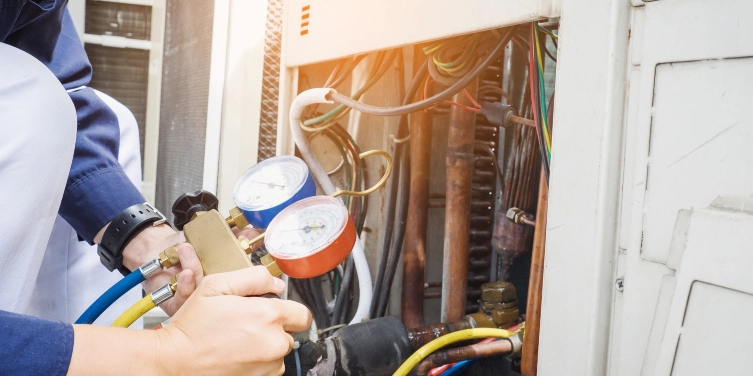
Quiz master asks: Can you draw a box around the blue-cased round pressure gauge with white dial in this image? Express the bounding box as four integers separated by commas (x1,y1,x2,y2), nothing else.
233,155,316,228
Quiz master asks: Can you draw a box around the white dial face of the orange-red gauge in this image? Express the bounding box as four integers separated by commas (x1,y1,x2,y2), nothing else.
264,196,348,258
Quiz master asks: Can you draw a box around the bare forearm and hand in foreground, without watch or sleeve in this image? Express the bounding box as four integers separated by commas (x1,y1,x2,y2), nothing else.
68,266,311,375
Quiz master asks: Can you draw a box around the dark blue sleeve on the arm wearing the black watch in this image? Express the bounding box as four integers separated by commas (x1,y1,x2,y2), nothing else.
0,0,145,243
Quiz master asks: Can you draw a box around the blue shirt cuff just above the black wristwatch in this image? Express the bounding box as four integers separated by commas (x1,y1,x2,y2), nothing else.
60,167,146,244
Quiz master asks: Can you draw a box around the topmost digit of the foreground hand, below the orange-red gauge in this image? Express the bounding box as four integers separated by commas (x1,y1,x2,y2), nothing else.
197,266,285,296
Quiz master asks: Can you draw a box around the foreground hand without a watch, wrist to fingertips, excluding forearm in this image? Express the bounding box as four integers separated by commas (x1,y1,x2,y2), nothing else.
156,266,311,375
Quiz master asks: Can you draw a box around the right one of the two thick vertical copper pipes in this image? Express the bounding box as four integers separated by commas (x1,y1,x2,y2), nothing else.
441,80,478,322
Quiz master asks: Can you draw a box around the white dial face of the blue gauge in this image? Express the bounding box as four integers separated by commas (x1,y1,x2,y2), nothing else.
233,155,309,211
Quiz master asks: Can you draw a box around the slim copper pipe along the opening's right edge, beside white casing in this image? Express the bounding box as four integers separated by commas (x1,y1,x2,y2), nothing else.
520,169,549,376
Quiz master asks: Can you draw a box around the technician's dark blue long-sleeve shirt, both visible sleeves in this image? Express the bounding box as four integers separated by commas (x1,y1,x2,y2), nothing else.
0,0,145,375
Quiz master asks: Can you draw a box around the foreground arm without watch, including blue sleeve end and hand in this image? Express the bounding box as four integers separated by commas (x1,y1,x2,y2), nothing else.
0,267,311,376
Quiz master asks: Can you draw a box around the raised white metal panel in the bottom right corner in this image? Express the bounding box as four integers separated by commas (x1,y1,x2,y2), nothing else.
653,208,753,375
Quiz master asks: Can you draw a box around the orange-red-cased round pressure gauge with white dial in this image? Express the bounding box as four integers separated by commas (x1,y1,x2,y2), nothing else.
264,196,356,278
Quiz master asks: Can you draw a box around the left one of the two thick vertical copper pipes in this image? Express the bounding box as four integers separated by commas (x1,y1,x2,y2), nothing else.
400,106,432,328
